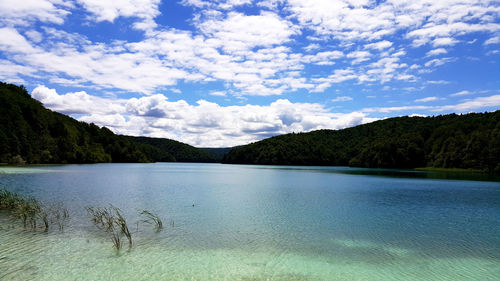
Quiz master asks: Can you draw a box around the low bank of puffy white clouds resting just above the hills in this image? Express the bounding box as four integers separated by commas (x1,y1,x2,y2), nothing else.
31,86,376,147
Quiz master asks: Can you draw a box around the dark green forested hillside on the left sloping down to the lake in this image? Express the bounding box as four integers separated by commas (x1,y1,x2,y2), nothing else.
0,82,215,164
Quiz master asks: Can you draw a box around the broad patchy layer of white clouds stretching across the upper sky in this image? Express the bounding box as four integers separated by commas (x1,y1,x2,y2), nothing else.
0,0,500,96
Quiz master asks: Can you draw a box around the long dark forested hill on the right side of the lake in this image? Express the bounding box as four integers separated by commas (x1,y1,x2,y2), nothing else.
223,111,500,173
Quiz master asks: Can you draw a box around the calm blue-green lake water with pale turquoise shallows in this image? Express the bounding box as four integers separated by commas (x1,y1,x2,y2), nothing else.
0,163,500,281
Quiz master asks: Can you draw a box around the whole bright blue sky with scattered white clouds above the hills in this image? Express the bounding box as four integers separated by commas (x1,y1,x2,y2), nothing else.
0,0,500,147
